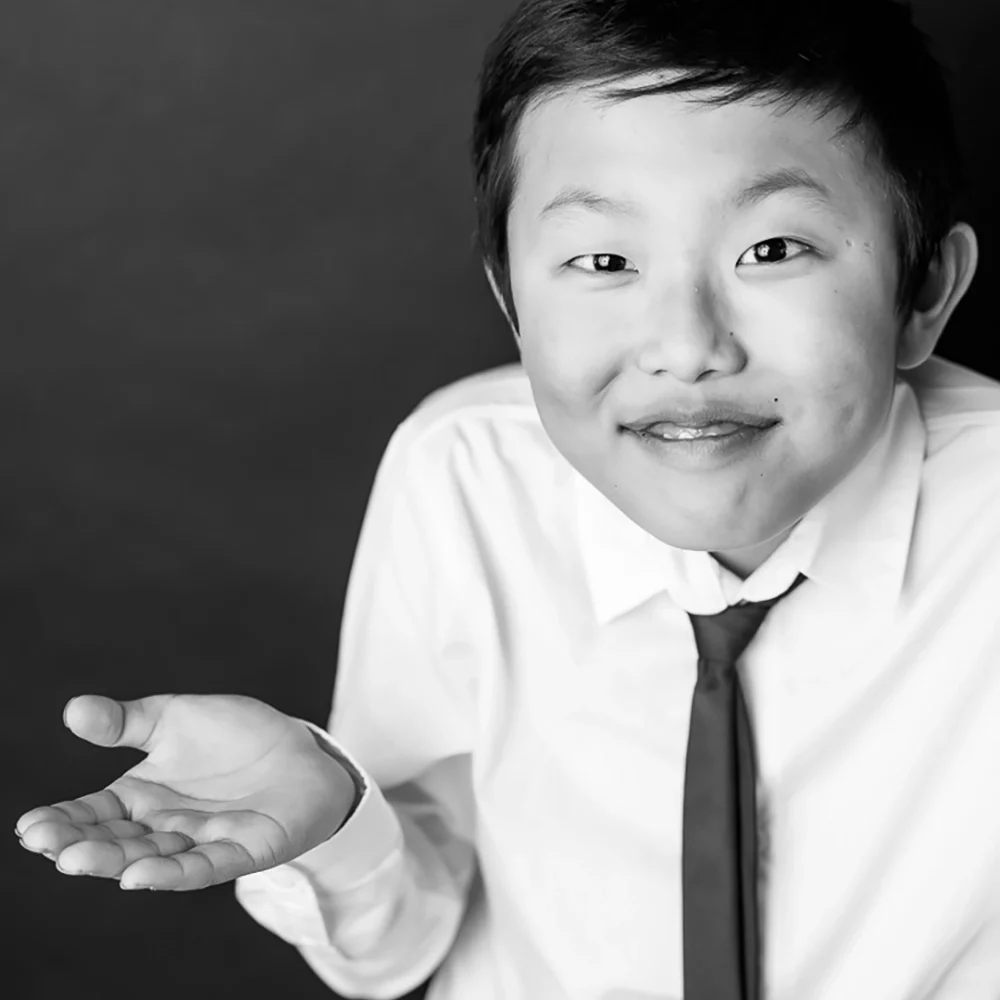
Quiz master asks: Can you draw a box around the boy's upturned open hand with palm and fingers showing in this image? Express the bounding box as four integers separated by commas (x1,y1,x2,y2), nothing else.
16,695,355,889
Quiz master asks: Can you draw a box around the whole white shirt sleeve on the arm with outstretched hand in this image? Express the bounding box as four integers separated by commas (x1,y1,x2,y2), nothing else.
236,410,477,1000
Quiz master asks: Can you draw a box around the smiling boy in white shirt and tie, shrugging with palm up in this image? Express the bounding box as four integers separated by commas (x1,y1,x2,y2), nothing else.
11,0,1000,1000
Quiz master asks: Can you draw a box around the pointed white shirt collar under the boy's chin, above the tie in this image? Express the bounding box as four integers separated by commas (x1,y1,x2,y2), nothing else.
572,379,926,624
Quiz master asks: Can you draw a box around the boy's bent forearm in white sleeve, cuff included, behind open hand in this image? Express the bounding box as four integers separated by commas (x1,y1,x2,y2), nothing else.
236,728,475,998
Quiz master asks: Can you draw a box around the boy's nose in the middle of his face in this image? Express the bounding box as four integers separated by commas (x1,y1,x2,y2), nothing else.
636,282,747,383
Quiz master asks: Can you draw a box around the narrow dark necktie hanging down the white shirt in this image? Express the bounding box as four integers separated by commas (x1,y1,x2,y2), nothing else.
682,574,805,1000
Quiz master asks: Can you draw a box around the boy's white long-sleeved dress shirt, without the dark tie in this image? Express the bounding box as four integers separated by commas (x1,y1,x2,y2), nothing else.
236,357,1000,1000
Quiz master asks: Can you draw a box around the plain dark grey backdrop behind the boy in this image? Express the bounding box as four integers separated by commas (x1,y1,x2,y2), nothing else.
0,0,1000,1000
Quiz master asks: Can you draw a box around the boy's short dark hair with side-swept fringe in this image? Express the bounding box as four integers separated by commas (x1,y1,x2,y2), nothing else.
472,0,962,326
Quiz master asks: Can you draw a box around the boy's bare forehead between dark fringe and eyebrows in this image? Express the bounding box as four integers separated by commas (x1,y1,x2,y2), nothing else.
511,78,886,226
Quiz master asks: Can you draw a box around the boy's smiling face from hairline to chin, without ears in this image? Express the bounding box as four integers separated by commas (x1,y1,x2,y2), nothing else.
508,80,900,573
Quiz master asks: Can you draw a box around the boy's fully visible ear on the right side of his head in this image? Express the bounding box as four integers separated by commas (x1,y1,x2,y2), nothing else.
896,222,979,370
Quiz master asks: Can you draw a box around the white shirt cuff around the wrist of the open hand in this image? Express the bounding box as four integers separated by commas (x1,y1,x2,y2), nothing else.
278,719,403,891
